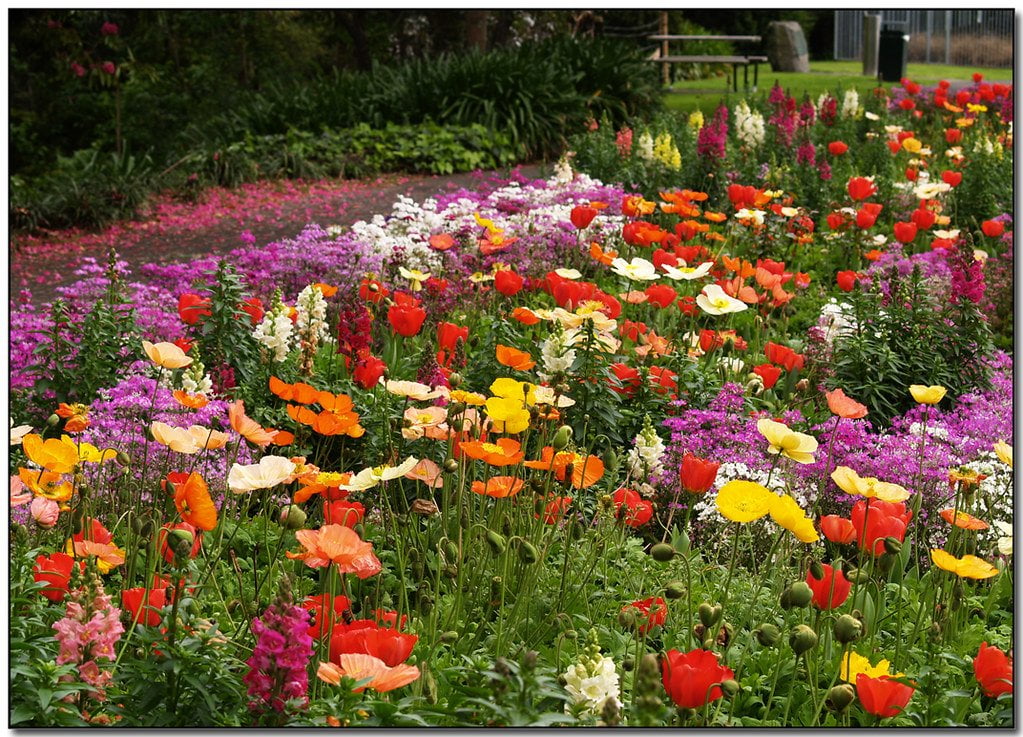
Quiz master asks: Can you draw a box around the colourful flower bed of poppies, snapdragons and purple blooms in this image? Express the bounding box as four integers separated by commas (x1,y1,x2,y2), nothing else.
10,72,1014,726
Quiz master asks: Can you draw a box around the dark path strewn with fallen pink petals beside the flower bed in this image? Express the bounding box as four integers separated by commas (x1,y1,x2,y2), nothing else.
8,165,541,304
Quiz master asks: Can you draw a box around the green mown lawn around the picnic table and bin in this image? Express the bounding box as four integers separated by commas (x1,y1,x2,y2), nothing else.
664,61,1013,115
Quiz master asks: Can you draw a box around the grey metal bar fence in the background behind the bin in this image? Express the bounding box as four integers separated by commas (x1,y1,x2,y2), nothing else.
835,10,1015,69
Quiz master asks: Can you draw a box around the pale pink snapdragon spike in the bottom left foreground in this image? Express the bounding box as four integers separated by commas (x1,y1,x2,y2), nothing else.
53,580,125,700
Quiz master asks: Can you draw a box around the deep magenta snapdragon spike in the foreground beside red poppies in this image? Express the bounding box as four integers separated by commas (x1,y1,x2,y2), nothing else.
242,600,313,712
